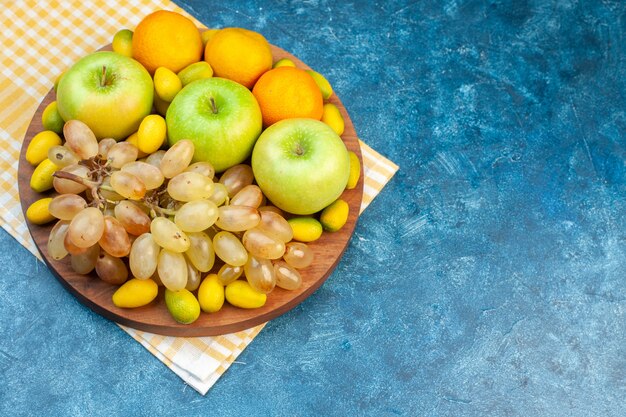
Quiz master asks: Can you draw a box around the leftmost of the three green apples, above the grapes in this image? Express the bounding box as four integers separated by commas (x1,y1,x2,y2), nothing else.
57,51,154,140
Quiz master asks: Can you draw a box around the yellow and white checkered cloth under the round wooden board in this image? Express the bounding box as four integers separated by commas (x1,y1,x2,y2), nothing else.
0,0,398,394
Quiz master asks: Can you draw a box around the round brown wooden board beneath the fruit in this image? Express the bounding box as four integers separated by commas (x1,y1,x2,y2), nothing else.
18,45,363,337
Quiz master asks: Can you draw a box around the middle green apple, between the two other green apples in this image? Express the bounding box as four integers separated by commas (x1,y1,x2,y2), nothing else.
165,78,263,172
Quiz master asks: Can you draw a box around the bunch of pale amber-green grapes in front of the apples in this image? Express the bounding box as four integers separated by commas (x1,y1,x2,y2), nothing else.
47,120,313,300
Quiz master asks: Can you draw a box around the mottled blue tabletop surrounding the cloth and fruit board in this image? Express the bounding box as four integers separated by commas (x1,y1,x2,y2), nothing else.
0,0,626,416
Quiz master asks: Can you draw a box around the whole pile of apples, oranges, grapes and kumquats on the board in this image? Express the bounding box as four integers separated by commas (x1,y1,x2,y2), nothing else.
25,11,360,324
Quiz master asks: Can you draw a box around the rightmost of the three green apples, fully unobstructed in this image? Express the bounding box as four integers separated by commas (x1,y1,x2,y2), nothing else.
252,119,350,215
